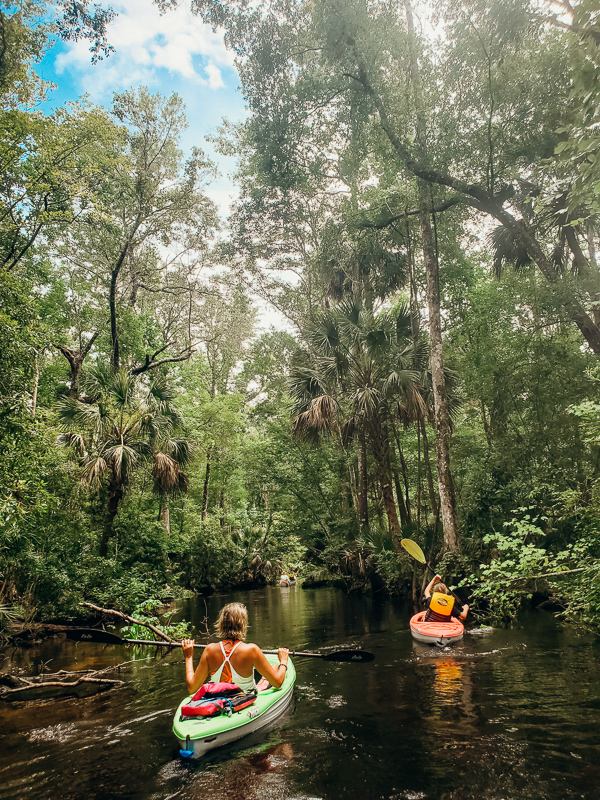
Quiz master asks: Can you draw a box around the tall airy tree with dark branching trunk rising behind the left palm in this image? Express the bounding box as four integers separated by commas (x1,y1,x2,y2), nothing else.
50,89,216,396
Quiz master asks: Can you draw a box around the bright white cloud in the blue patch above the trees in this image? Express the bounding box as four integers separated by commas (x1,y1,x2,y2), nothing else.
55,0,233,101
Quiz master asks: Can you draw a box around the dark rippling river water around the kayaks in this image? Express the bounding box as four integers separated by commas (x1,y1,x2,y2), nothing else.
0,587,600,800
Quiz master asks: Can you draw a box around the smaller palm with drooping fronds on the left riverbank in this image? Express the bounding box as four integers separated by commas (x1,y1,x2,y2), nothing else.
56,367,190,556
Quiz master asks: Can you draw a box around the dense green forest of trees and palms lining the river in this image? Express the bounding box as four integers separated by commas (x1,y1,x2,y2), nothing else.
0,0,600,633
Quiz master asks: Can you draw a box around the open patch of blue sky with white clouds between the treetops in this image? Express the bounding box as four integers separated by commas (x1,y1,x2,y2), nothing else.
38,0,246,217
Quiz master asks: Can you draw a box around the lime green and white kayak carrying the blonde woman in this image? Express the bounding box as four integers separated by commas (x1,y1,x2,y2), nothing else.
173,655,296,758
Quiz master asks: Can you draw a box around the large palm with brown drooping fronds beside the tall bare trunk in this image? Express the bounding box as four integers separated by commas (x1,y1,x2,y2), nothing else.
290,299,425,547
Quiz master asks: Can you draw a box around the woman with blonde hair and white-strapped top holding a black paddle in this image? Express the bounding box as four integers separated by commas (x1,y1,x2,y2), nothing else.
181,603,289,694
